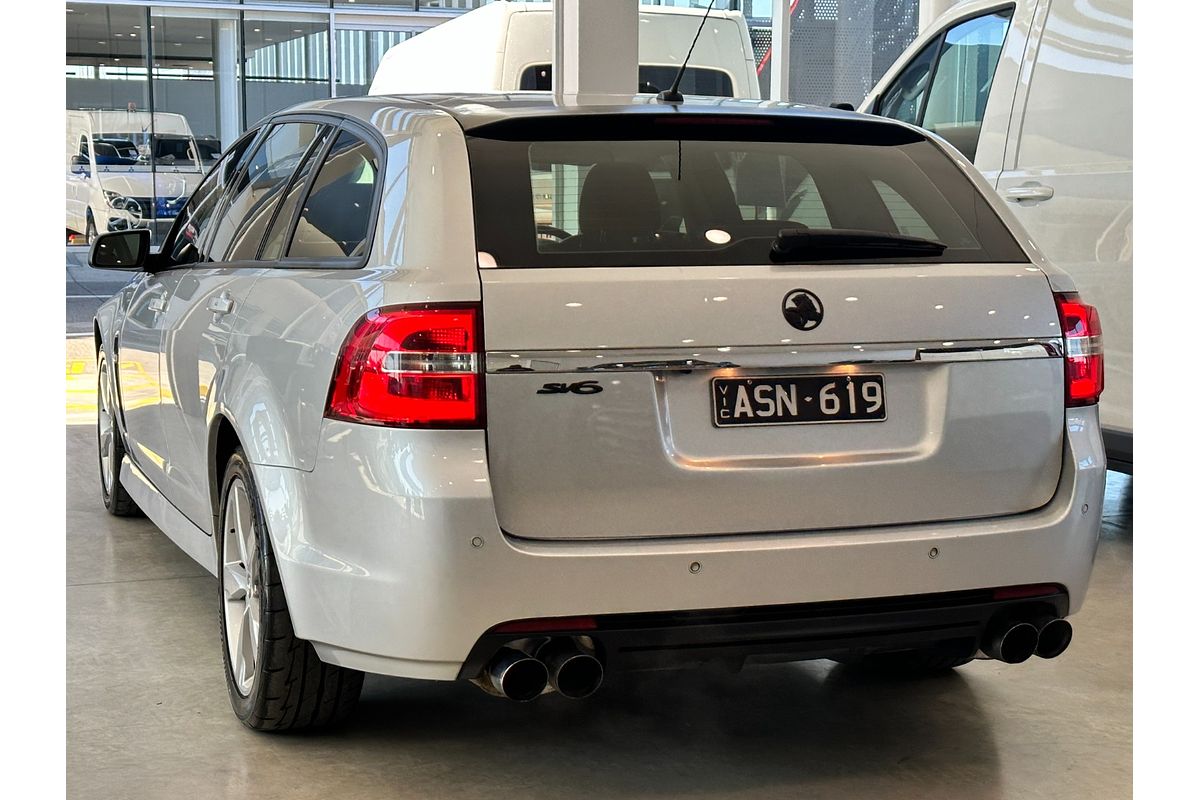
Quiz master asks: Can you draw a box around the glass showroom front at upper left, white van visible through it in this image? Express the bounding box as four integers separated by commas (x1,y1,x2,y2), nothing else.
64,0,472,241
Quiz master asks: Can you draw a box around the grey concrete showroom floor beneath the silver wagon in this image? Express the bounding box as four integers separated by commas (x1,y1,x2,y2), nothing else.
66,417,1133,800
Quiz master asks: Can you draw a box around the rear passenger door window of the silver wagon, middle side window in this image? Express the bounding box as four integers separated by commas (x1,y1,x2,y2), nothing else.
210,122,324,261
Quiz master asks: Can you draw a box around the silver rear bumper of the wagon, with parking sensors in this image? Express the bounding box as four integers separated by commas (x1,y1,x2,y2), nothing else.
254,408,1105,680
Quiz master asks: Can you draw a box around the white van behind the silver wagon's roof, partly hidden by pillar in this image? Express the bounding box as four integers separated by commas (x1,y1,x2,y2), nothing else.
371,2,760,100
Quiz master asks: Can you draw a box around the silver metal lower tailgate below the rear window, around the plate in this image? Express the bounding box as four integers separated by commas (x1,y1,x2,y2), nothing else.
481,265,1063,539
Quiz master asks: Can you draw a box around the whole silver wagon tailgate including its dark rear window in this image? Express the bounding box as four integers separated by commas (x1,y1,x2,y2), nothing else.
468,109,1063,540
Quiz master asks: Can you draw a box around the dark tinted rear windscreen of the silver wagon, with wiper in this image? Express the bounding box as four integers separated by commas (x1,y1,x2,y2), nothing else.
468,114,1027,267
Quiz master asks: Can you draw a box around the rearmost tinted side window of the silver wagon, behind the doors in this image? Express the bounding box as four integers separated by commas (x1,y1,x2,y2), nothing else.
288,131,379,258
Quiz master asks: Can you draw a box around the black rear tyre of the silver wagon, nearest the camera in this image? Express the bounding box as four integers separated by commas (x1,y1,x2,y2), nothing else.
216,447,362,732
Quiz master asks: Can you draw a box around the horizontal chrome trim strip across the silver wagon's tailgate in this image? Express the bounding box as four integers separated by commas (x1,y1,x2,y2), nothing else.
485,336,1063,374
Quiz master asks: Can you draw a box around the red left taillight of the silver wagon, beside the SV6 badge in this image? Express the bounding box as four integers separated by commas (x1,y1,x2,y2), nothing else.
325,305,484,428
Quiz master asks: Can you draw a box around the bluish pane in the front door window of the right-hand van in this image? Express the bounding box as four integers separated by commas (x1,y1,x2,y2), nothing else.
920,11,1013,160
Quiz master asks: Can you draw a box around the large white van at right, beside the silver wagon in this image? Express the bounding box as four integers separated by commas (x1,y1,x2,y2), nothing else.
859,0,1133,471
